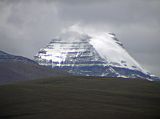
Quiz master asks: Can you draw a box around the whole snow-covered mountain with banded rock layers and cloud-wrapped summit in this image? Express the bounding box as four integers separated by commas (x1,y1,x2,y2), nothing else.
35,27,158,80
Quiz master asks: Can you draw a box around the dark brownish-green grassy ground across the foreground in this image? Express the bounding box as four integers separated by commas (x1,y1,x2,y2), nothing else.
0,77,160,119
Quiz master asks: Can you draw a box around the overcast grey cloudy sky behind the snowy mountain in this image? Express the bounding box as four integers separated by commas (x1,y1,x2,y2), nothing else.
0,0,160,76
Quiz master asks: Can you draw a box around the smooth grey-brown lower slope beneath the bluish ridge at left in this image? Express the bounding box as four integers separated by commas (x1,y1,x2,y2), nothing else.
0,62,67,84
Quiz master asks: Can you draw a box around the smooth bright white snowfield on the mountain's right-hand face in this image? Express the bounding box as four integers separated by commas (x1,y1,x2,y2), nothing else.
90,33,144,71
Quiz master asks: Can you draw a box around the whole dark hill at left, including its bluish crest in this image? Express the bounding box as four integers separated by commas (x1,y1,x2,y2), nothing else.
0,51,66,85
